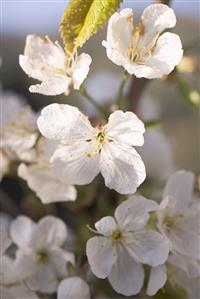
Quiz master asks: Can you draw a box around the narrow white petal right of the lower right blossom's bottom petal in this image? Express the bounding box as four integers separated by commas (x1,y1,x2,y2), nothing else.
147,265,167,296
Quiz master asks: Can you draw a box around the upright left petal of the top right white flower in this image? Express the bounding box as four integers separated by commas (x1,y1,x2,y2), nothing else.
103,8,133,65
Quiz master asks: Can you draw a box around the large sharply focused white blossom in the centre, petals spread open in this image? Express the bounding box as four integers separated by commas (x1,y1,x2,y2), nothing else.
37,104,145,194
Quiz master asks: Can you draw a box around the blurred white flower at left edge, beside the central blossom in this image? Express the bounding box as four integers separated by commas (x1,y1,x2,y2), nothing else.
0,92,39,169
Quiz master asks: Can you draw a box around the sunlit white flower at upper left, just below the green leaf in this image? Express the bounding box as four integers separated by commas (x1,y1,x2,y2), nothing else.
19,35,92,95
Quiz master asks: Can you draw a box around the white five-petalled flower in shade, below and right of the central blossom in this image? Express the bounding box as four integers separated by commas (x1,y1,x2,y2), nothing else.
86,196,169,296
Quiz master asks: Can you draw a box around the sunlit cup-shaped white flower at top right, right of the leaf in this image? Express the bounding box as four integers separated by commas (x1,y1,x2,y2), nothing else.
103,4,183,79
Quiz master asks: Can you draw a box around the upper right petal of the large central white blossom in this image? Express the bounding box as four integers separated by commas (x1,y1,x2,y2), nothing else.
105,111,145,146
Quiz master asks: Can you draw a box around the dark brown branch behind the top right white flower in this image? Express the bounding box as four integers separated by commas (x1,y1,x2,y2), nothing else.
127,0,171,112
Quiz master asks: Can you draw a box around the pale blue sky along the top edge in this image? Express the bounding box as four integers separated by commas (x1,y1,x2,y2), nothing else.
1,0,200,36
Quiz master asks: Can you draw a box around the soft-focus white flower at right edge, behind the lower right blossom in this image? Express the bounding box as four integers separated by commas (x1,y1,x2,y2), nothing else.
157,171,200,259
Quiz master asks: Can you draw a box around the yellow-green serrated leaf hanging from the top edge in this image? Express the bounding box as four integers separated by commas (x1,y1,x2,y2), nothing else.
60,0,122,54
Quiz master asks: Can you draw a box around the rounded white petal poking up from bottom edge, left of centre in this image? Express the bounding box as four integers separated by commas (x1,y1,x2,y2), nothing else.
57,277,90,299
